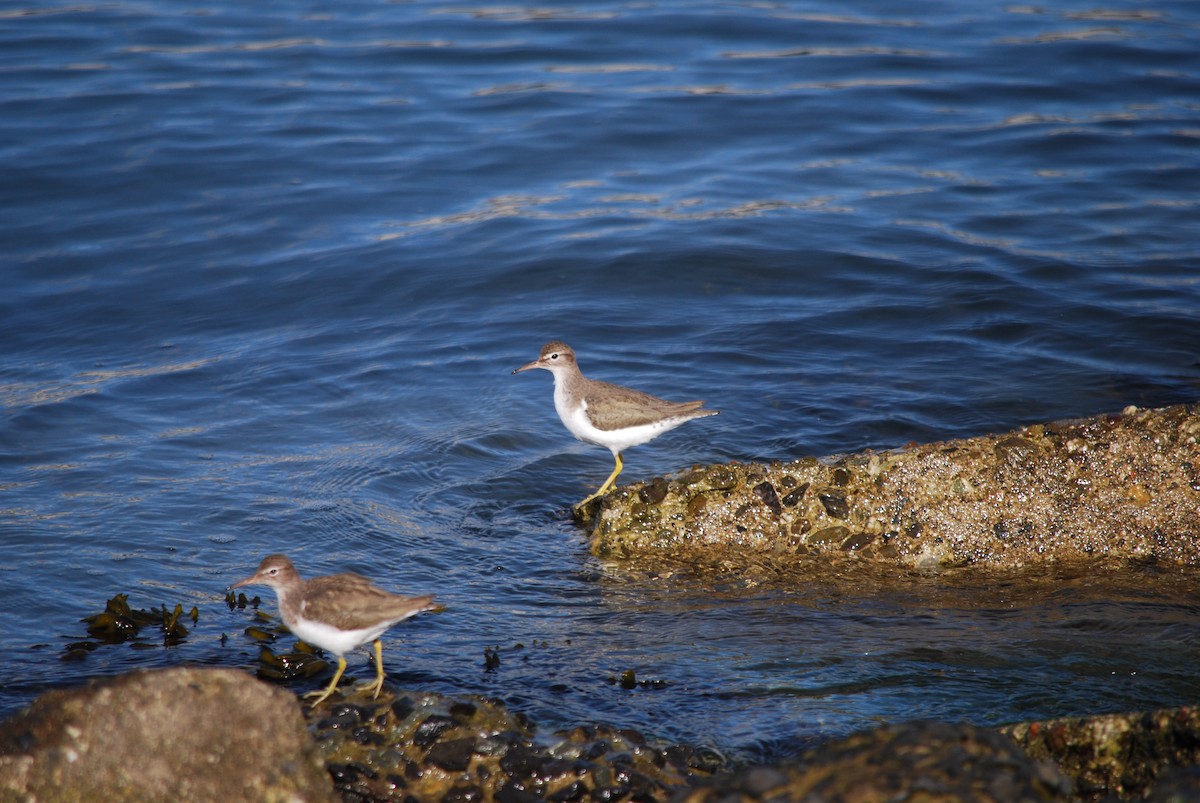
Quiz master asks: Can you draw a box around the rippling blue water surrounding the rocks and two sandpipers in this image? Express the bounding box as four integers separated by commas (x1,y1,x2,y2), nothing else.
0,0,1200,756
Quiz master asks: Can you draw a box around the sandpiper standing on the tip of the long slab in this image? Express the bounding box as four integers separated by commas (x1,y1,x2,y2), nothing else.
512,340,718,510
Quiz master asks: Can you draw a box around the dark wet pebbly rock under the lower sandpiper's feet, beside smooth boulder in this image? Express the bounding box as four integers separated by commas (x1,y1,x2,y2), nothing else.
308,690,727,801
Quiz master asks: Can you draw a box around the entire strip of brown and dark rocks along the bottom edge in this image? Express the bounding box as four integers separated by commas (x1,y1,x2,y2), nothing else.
0,667,1200,803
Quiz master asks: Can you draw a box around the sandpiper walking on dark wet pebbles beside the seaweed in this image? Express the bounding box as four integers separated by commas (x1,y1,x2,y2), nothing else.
229,555,433,706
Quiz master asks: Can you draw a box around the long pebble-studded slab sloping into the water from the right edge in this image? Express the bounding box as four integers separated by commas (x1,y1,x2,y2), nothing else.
581,405,1200,568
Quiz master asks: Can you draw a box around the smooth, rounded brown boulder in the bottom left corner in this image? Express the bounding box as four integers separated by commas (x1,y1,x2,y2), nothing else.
0,669,336,801
